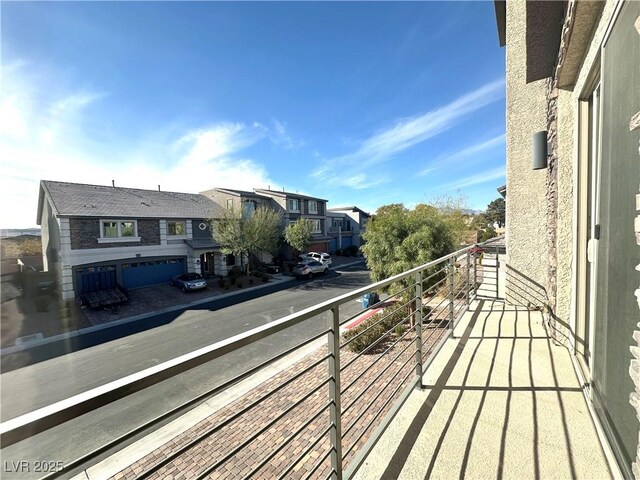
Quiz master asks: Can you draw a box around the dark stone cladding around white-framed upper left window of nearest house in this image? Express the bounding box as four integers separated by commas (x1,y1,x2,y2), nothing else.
69,218,160,250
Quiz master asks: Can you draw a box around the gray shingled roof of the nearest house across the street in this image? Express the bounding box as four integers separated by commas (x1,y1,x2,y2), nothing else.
40,180,220,218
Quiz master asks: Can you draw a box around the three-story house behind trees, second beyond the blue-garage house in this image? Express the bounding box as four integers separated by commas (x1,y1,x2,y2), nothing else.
254,188,331,252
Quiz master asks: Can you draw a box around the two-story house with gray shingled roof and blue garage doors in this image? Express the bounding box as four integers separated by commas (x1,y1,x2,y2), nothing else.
37,180,241,300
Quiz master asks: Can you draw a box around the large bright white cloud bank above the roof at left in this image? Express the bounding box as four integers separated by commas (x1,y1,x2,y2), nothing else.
0,61,275,228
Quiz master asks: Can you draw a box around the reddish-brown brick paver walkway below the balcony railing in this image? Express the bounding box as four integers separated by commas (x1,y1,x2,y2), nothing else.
113,321,447,480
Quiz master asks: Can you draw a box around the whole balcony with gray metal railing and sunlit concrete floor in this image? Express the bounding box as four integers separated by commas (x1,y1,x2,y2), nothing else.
1,238,611,480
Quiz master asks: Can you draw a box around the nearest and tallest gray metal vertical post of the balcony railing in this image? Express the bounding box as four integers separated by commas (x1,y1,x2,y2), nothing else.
328,305,342,480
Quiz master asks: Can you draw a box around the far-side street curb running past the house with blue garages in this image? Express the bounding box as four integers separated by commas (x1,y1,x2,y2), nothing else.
0,277,294,357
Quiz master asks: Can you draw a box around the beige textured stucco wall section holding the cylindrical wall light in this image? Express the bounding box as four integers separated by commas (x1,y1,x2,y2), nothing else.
506,0,547,305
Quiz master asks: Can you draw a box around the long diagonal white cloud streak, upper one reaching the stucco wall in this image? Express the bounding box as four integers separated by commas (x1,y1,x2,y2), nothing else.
313,79,504,185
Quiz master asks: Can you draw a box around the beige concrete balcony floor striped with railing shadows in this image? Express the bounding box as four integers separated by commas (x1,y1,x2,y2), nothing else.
355,300,611,480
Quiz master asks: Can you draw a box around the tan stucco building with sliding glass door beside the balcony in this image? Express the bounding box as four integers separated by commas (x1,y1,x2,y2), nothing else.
494,0,640,478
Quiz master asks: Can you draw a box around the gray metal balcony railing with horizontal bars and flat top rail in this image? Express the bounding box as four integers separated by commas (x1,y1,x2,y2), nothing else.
0,238,500,479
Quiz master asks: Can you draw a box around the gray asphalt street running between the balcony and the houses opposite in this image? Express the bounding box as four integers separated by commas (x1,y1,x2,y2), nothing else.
0,265,370,478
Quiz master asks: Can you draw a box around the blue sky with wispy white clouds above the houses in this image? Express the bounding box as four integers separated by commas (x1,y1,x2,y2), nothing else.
0,2,505,228
